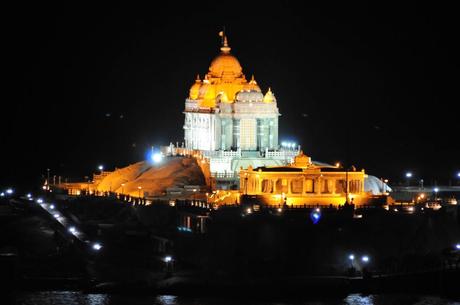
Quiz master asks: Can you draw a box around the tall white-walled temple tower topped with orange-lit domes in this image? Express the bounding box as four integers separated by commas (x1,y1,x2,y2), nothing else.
184,34,298,179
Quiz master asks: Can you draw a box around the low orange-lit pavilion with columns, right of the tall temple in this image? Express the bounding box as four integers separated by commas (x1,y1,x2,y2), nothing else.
240,151,386,207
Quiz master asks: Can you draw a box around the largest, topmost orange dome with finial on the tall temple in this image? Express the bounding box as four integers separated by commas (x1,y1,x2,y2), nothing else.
209,36,243,78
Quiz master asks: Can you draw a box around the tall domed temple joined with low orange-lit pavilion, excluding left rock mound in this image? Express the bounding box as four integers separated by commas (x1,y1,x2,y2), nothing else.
180,33,390,205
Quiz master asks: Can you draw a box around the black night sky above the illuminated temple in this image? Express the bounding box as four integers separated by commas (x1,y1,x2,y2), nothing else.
0,1,460,186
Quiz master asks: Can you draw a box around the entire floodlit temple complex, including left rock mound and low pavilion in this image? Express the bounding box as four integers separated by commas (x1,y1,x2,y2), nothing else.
56,34,390,205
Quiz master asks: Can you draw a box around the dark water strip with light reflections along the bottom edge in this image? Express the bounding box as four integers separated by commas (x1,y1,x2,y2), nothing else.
10,291,460,305
